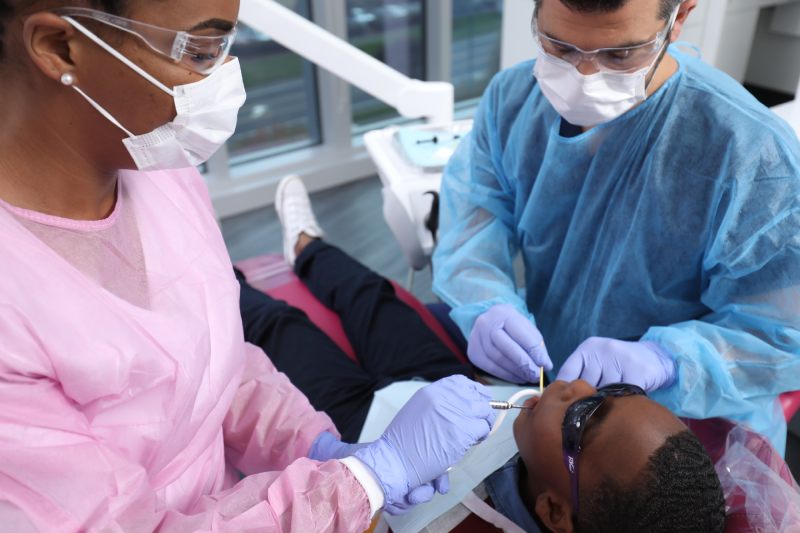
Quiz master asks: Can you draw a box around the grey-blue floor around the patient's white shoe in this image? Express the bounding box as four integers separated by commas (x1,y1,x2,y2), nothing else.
222,177,800,478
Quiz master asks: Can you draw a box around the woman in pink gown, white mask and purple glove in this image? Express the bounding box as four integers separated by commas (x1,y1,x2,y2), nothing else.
0,0,493,531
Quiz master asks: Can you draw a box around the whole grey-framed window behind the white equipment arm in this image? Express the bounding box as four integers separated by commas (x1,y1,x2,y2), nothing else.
212,0,503,217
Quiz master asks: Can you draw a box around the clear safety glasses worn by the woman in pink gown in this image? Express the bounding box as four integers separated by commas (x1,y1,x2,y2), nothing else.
52,7,236,75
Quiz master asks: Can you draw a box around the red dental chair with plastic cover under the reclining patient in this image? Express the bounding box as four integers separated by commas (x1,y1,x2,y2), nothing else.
236,254,800,533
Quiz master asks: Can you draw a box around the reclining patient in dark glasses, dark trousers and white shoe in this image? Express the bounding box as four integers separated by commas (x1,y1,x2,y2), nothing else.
237,178,725,533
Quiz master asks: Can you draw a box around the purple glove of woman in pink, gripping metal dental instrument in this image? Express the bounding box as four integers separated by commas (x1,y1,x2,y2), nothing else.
353,376,495,513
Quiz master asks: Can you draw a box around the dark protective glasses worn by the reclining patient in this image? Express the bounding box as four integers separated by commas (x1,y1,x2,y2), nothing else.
561,383,647,523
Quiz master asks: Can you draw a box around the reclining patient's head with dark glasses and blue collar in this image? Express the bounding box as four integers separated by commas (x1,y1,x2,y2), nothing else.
485,380,725,533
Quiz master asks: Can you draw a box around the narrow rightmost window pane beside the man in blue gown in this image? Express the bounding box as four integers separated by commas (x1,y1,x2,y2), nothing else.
452,0,503,101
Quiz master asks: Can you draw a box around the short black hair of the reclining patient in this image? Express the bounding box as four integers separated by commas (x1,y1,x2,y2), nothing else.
576,431,725,533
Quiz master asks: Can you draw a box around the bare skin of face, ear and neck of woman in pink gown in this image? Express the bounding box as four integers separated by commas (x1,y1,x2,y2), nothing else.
0,0,239,197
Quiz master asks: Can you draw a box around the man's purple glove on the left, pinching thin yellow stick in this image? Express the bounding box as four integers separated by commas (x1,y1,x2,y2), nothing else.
467,304,553,383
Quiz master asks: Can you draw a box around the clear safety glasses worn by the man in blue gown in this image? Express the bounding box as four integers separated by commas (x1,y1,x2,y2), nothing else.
531,9,678,72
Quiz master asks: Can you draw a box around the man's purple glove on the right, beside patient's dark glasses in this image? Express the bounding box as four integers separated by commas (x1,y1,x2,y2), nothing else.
557,337,676,392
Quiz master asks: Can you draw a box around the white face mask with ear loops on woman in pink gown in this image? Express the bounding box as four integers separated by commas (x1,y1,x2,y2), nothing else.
62,17,246,170
